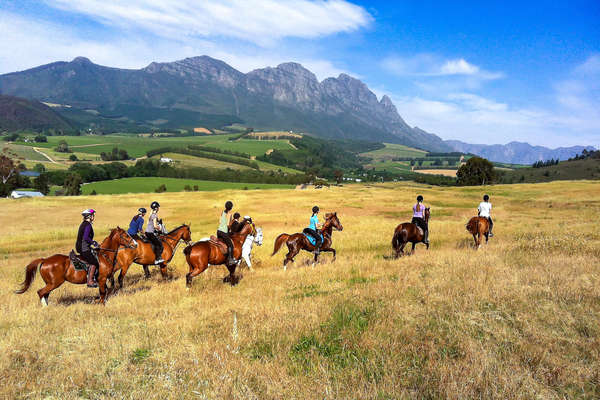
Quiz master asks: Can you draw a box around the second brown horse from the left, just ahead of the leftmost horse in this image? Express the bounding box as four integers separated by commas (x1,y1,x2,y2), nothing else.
110,224,192,288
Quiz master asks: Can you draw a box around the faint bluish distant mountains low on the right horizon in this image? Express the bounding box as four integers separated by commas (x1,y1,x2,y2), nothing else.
445,140,594,165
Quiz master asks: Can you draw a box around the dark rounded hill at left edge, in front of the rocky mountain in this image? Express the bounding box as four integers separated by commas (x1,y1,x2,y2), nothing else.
0,95,73,132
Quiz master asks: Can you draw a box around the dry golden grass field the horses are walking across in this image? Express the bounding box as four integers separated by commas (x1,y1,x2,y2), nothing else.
0,182,600,399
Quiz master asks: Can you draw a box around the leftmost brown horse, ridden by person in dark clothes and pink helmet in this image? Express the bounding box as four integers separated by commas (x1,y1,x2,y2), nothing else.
15,227,137,306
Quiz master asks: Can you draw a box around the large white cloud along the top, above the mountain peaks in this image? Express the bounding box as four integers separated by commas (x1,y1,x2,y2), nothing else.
46,0,373,45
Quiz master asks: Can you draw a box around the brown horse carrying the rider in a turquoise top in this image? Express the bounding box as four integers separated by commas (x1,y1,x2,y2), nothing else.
271,212,344,271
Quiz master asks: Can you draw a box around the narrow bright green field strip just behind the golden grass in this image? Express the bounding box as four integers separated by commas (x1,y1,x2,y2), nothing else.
81,178,294,194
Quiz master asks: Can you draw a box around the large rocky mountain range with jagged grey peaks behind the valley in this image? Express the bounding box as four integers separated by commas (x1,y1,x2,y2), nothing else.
0,56,450,151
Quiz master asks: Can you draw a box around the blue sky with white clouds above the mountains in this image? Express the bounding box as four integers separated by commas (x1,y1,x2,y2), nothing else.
0,0,600,147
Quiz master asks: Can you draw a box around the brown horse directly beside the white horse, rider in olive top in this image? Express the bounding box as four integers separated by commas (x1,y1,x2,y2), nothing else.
183,222,256,289
